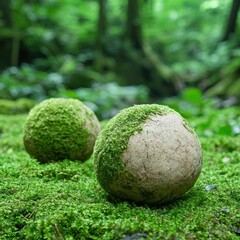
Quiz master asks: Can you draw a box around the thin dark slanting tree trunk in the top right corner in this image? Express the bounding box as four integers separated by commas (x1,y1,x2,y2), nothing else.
223,0,240,41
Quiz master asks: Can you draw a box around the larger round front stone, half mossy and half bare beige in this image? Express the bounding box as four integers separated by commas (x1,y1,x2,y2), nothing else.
94,104,202,204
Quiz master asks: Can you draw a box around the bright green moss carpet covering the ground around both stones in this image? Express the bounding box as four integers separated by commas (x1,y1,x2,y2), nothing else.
0,109,240,240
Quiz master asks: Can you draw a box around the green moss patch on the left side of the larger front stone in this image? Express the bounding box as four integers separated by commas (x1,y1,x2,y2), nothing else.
94,104,177,190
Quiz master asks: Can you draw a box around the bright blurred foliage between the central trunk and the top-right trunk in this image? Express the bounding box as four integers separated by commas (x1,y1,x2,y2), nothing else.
143,0,231,82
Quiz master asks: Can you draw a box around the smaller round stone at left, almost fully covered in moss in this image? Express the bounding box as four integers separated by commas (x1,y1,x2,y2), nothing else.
23,98,100,162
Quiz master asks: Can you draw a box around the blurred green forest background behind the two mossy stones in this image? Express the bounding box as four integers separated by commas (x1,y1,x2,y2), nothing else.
0,0,240,119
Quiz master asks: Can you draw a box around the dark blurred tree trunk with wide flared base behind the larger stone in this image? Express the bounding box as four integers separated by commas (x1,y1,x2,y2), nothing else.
116,0,175,97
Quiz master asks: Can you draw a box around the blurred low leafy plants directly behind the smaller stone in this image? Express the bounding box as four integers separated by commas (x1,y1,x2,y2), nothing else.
0,62,149,119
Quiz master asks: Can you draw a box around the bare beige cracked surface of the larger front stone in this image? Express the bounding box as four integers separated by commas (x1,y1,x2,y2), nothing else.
106,113,202,204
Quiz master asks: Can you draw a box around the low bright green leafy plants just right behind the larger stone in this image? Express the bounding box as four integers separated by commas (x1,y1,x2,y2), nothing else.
162,88,240,138
